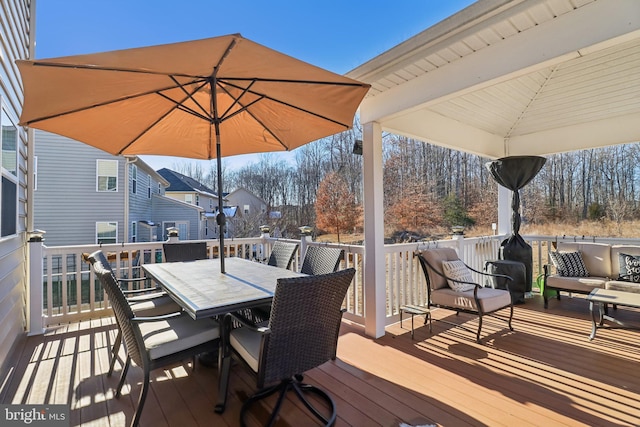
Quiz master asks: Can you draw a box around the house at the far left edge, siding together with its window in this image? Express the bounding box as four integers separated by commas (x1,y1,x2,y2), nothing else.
0,0,35,370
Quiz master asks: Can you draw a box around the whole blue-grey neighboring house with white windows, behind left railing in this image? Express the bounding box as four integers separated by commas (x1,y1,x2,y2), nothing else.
33,130,202,246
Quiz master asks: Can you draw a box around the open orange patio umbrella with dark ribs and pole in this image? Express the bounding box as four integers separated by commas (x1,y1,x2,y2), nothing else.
16,34,369,272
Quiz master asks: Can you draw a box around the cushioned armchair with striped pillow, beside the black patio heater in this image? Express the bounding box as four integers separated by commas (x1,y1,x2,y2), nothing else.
415,248,513,343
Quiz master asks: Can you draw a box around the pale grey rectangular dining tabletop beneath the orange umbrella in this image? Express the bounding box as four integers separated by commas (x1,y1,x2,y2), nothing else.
142,257,304,319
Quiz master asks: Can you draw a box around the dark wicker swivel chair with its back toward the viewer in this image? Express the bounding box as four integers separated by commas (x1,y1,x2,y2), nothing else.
216,268,355,425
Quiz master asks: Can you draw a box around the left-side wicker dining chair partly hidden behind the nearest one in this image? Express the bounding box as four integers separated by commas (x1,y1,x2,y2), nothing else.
87,251,182,377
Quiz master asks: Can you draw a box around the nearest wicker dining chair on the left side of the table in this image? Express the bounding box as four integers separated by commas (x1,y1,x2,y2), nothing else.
93,251,220,426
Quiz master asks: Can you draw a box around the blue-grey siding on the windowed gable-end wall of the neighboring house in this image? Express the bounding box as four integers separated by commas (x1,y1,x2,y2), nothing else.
34,130,129,246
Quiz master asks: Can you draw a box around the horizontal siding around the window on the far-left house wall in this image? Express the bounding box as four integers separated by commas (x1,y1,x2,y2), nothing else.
0,0,35,373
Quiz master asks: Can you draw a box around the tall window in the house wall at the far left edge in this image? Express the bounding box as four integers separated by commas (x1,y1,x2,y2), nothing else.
0,108,18,237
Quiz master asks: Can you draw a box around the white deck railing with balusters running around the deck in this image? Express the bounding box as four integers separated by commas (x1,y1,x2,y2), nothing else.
31,235,640,326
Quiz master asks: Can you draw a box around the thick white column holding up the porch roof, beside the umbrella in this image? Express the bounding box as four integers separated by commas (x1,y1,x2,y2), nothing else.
362,122,386,338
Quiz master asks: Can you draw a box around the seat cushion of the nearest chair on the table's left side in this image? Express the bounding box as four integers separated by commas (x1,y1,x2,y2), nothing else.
139,313,220,360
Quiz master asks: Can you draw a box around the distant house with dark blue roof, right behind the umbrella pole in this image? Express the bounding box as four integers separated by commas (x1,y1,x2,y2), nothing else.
158,168,226,239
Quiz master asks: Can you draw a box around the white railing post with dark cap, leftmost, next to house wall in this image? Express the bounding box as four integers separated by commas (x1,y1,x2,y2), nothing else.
27,230,44,336
